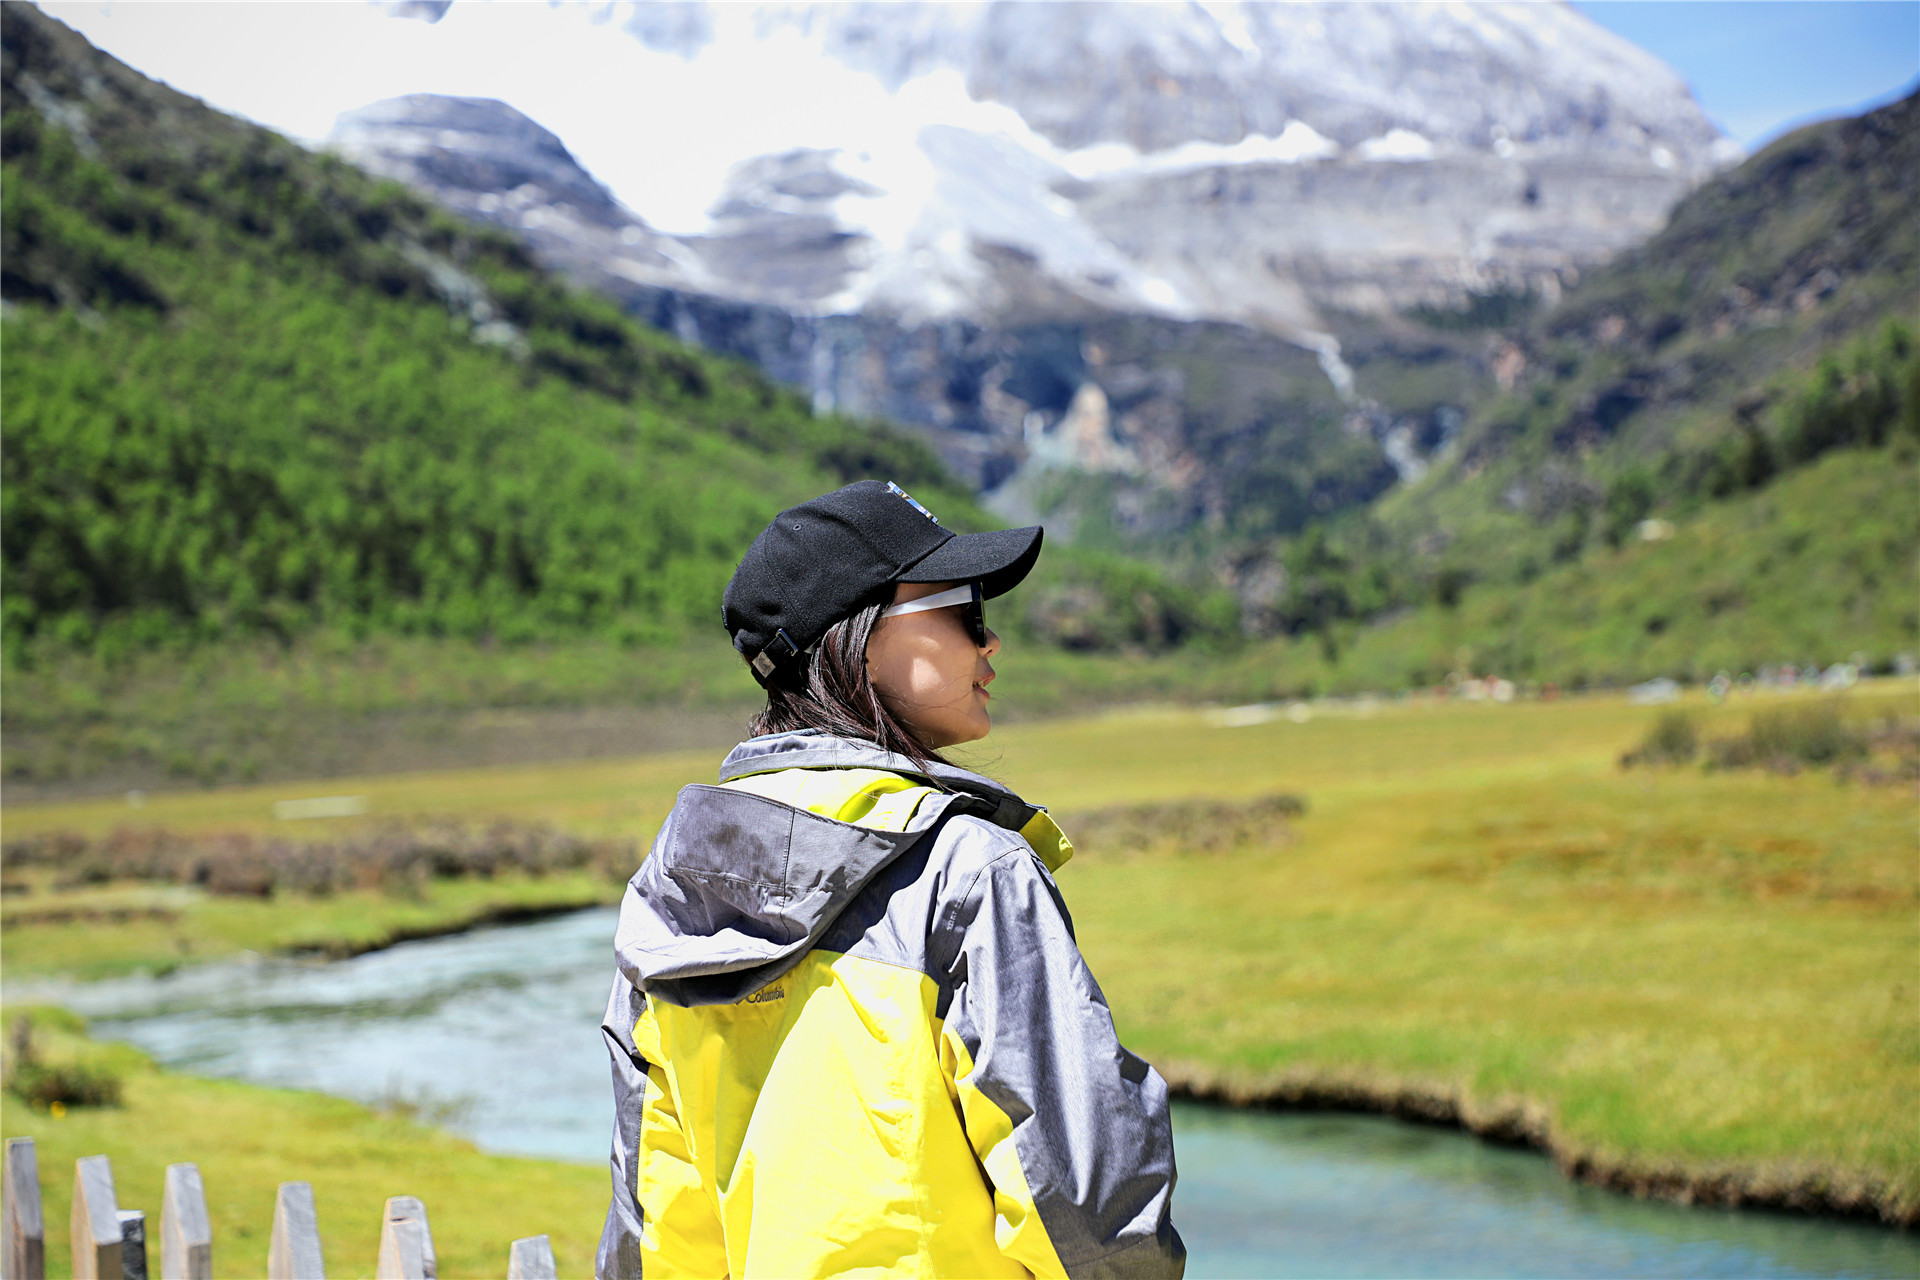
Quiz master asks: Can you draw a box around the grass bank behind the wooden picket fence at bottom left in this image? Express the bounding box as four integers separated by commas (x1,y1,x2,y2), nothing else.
0,1011,607,1278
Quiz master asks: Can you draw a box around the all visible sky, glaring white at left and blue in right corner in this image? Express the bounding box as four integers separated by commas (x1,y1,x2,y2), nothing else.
44,0,1920,232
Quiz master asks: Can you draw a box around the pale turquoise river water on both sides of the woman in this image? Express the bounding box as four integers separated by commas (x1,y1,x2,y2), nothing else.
33,910,1920,1276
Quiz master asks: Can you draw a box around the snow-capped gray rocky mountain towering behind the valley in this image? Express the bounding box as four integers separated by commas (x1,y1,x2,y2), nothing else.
332,0,1738,486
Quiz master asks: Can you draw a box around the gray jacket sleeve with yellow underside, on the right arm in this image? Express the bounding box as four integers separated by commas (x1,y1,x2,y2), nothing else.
937,836,1187,1280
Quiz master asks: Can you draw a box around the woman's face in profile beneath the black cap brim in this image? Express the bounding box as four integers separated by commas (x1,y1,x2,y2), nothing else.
866,581,1000,750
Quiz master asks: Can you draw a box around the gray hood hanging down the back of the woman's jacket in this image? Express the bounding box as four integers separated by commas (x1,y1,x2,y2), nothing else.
614,731,1039,1006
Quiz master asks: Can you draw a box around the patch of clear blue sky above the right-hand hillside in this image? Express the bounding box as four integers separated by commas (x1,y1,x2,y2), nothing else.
1574,0,1920,152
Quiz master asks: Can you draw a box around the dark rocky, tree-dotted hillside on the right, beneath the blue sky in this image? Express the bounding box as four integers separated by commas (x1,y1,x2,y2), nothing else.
1265,96,1920,660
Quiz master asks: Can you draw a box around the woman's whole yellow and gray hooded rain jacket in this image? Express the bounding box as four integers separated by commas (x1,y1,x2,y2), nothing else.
597,733,1187,1278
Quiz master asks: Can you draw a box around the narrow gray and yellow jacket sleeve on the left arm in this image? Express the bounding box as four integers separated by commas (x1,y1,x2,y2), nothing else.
593,975,728,1280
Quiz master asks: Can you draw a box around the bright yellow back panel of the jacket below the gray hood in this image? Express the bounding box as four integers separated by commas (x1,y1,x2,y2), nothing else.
636,952,1052,1278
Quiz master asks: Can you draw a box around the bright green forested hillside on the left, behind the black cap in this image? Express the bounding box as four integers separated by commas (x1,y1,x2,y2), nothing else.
0,4,981,654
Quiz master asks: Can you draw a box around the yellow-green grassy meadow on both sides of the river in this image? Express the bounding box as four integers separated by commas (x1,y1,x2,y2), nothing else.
0,681,1920,1276
